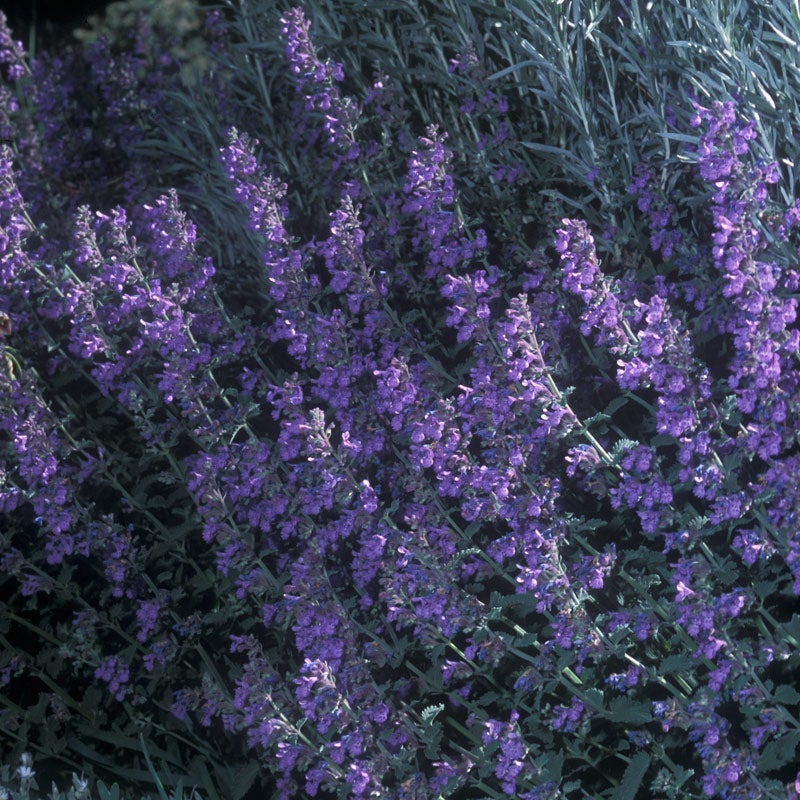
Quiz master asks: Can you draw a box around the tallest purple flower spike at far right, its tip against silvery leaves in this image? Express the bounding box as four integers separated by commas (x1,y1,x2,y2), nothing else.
695,104,800,459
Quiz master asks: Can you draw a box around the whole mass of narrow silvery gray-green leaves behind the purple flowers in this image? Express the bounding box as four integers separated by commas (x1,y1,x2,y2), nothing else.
139,0,800,282
